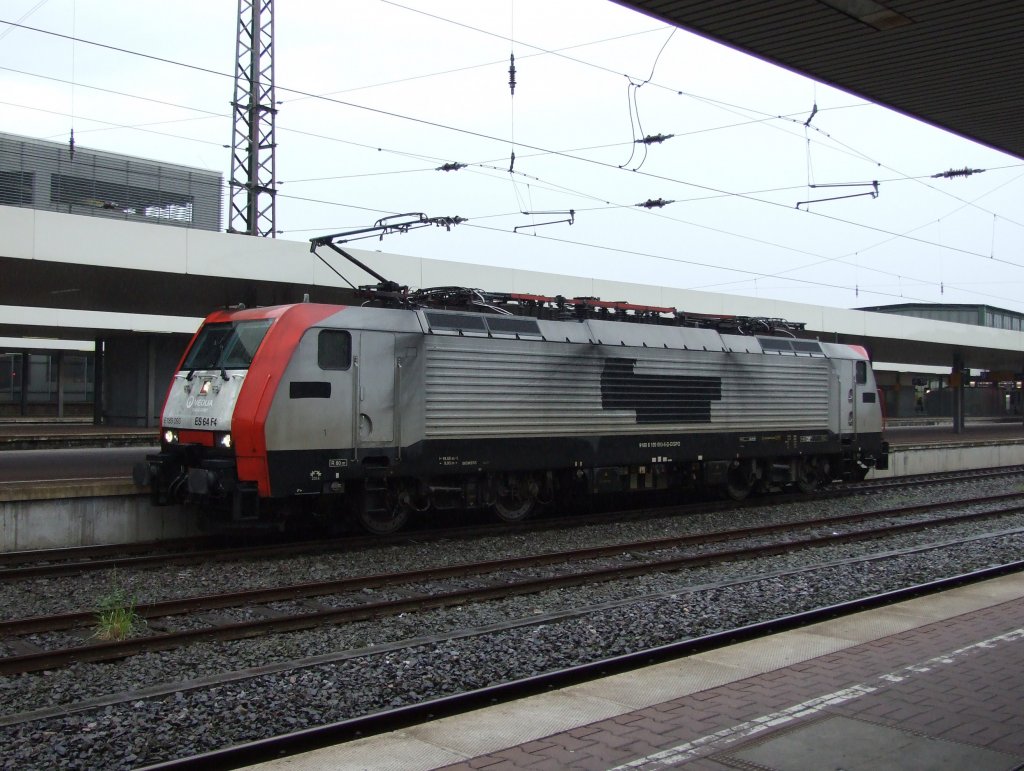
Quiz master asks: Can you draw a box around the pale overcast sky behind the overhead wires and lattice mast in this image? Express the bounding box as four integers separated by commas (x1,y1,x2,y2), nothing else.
0,0,1024,311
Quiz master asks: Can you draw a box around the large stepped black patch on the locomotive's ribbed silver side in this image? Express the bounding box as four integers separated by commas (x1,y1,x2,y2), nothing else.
601,358,722,423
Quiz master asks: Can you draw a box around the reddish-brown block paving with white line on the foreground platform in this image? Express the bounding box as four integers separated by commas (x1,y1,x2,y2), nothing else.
430,591,1024,771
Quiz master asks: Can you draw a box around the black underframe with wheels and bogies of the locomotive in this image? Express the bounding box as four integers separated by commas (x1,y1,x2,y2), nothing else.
147,431,888,532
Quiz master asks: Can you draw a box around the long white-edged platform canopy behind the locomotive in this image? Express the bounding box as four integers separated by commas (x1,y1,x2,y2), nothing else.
0,207,1024,373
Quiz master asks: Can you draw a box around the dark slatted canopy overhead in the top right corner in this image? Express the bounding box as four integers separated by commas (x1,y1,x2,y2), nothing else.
615,0,1024,158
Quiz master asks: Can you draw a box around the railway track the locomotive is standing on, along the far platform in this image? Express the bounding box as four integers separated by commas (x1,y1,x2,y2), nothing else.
0,466,1024,582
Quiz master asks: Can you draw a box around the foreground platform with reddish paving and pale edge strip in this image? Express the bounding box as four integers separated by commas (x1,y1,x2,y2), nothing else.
251,574,1024,771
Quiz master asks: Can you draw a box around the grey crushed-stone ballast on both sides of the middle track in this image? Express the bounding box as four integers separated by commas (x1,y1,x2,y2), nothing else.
0,477,1024,770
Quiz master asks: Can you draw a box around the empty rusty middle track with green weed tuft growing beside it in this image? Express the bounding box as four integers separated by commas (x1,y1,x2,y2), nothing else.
0,492,1024,674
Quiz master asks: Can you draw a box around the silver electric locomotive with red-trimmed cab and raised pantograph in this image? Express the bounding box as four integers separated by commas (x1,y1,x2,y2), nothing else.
136,287,888,533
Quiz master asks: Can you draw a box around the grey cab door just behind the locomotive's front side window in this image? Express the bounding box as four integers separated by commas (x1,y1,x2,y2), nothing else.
355,332,395,447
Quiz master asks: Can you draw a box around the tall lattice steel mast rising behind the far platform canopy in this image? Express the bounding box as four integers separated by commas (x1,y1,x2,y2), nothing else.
227,0,278,239
